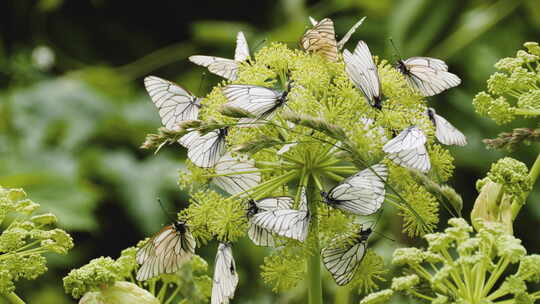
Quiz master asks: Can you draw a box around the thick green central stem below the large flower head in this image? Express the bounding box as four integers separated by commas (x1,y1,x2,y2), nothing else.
306,180,322,304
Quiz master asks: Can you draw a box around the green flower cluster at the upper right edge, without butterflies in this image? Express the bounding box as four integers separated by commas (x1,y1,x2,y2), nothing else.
473,42,540,124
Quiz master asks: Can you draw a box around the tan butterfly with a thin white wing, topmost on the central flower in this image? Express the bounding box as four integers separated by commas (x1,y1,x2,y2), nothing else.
300,17,366,61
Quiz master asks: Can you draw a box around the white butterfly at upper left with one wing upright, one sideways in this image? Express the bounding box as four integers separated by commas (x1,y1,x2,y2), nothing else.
189,32,249,80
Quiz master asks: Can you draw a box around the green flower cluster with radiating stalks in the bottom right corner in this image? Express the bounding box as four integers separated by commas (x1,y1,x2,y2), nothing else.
360,218,540,304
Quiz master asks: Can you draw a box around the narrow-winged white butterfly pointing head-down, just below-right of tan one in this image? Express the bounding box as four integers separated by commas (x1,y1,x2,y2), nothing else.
343,40,382,109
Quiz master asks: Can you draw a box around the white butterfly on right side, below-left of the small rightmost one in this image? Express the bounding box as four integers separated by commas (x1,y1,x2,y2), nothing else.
383,126,431,172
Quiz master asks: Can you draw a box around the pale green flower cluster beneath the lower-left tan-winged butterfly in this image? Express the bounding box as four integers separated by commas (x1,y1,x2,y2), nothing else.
64,246,212,304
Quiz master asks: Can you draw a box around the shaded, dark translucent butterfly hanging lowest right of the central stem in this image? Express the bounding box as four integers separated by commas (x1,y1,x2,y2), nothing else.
321,228,372,286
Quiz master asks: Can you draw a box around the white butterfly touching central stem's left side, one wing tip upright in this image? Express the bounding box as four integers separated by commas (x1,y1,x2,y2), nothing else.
252,189,311,242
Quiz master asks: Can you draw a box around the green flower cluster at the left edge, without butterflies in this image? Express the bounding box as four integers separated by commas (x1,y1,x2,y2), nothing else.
0,187,73,295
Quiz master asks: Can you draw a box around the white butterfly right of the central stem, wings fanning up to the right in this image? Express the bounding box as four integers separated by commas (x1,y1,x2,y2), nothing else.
321,164,388,215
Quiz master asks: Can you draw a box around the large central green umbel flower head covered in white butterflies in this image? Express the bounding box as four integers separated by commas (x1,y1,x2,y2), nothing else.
139,18,465,293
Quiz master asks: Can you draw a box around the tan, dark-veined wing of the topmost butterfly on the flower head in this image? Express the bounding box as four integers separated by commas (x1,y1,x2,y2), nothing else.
300,18,338,62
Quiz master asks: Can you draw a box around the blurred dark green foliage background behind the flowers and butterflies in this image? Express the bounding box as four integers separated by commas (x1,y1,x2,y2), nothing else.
0,0,540,304
